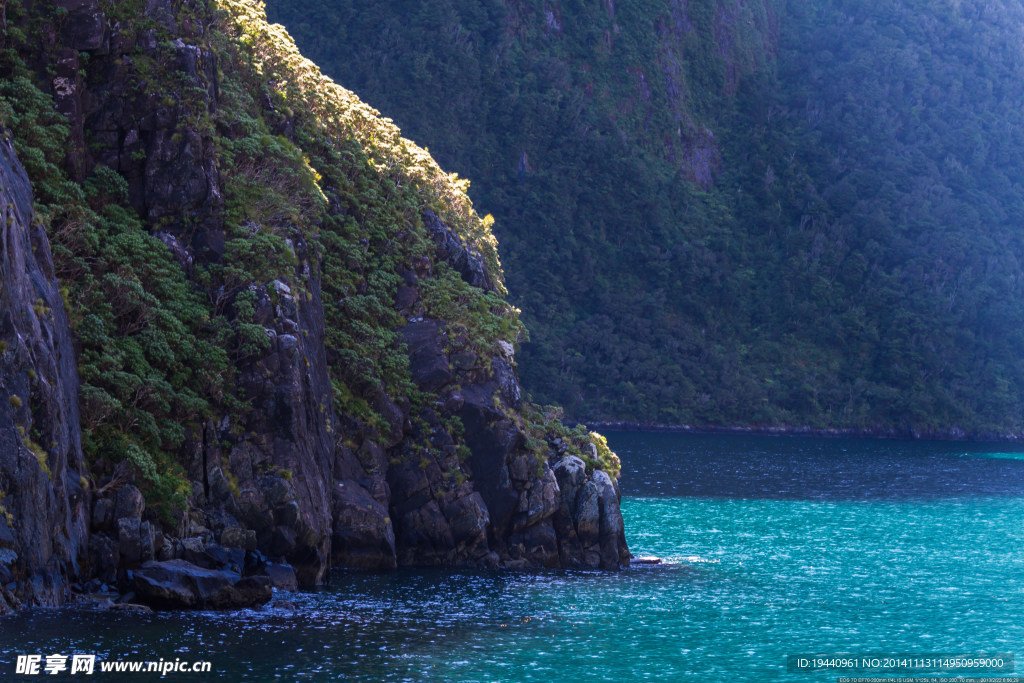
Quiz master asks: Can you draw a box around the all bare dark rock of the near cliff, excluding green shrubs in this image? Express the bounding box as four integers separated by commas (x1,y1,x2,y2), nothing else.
0,0,629,608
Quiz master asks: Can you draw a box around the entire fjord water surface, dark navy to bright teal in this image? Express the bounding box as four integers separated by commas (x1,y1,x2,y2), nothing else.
0,433,1024,683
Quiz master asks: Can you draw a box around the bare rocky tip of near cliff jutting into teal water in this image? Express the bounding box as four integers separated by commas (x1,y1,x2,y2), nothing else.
388,296,630,569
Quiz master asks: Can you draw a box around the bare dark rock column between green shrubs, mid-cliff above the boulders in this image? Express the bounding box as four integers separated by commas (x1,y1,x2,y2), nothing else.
199,264,339,586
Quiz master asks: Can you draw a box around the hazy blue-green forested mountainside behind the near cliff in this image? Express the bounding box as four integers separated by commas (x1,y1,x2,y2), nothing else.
267,0,1024,434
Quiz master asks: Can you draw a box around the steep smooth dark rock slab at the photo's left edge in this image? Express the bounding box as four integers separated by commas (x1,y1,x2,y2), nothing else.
0,135,88,612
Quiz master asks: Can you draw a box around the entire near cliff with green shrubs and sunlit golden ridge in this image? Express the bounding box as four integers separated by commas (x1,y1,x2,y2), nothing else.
0,0,629,609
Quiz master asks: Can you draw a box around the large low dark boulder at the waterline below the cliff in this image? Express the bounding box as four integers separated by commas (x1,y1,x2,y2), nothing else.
134,560,273,609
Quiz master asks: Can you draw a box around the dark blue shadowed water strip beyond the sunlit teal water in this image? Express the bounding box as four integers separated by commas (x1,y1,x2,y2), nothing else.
622,432,1024,501
